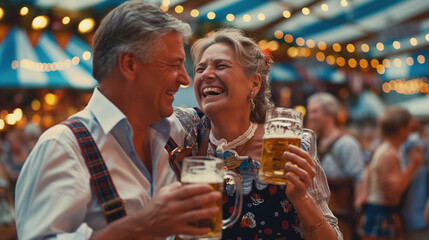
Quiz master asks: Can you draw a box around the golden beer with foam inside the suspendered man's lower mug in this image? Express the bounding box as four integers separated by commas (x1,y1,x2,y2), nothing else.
180,175,223,239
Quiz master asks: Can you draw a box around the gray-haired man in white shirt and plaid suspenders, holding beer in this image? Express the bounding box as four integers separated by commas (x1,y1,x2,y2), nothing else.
16,0,221,240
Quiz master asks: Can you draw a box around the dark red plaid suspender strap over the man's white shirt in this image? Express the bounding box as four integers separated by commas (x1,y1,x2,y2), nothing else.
62,119,126,223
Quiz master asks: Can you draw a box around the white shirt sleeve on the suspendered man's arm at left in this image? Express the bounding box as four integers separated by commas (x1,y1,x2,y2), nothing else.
15,126,92,240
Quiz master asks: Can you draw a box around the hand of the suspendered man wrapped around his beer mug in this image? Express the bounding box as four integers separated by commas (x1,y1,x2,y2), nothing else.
138,182,221,237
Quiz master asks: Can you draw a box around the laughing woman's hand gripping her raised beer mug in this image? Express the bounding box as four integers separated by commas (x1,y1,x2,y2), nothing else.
284,145,316,203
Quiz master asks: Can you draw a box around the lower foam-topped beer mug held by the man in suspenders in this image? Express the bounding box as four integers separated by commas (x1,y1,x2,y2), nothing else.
179,156,243,239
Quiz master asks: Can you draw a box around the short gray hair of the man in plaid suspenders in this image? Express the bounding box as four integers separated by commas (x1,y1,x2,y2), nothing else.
92,0,191,81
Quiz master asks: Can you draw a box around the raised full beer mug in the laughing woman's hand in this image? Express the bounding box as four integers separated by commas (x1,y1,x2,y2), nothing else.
258,107,310,185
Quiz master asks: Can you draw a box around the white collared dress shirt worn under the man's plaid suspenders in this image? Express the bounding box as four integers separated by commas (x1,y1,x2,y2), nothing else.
15,88,184,240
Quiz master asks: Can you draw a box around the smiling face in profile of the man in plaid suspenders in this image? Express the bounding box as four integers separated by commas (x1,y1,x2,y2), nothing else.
136,31,189,122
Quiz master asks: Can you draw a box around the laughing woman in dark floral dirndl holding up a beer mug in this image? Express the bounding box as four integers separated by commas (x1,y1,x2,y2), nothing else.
175,29,342,240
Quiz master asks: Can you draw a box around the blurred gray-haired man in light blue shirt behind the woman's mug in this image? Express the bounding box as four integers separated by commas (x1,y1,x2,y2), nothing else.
307,92,365,240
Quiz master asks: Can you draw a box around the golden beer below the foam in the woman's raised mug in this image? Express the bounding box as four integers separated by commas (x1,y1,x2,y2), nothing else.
258,137,301,185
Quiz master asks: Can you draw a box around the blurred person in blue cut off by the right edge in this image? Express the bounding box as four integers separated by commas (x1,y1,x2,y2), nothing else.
401,119,429,240
